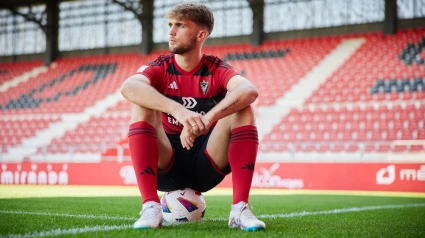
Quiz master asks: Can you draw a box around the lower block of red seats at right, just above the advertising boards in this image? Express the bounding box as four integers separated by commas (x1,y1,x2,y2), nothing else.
264,104,425,151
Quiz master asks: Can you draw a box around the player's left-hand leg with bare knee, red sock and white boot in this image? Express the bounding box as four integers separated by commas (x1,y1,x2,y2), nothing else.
128,105,173,229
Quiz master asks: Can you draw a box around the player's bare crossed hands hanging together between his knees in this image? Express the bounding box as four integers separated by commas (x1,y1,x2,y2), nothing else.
173,108,211,150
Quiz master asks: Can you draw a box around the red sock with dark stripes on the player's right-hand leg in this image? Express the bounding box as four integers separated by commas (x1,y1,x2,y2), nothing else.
229,125,258,204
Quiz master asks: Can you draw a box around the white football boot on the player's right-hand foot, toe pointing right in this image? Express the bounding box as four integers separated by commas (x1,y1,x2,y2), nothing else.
229,202,266,231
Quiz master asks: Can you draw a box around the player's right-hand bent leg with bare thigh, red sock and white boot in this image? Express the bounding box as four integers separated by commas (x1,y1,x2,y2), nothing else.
207,106,265,231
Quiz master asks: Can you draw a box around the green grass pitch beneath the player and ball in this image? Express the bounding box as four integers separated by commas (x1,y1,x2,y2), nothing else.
0,195,425,237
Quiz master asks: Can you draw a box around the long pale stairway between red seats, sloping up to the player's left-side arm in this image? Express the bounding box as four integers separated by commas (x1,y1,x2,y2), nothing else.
3,89,122,161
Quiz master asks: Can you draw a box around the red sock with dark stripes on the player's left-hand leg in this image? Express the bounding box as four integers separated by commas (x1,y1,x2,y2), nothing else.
128,121,159,203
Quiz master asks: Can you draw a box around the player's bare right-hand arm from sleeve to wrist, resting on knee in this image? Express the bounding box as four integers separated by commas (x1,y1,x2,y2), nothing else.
205,75,258,123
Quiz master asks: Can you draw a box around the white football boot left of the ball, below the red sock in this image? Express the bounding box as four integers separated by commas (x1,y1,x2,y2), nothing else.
133,202,163,229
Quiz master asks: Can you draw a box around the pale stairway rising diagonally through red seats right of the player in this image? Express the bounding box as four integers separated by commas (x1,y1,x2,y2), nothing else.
257,38,365,138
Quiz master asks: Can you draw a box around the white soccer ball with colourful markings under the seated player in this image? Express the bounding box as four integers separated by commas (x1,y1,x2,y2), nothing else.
161,188,206,224
